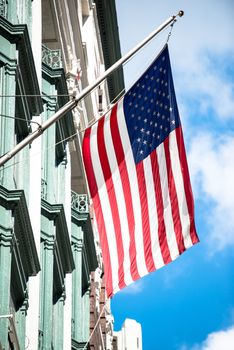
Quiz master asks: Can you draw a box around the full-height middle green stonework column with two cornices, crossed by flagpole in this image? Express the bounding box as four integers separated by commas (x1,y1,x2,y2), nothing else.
39,51,75,350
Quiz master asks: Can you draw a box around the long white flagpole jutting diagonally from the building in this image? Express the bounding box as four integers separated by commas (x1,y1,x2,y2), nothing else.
0,11,184,166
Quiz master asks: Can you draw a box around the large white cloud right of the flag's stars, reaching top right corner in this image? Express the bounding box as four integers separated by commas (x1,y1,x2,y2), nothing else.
169,0,234,120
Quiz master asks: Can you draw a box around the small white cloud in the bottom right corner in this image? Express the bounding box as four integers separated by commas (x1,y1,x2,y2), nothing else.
180,326,234,350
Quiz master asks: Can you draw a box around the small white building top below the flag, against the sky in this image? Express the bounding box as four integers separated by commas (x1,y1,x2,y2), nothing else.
114,318,142,350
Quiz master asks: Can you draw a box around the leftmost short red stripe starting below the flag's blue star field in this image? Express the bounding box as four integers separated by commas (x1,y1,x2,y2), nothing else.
136,162,155,272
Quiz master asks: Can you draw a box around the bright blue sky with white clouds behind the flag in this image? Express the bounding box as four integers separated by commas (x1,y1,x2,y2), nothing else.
111,0,234,350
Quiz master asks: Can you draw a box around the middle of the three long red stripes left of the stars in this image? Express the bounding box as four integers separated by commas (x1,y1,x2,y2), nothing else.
97,118,125,289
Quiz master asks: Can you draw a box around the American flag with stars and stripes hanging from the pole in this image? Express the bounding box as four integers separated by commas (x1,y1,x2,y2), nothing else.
83,45,198,296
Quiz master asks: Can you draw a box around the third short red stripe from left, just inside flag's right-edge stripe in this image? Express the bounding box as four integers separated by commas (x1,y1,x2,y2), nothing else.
164,136,185,254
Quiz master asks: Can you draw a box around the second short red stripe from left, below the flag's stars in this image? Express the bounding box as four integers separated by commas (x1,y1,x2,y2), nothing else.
150,150,172,264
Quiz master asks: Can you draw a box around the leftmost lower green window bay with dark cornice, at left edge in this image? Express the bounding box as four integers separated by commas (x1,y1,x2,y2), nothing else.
0,186,40,348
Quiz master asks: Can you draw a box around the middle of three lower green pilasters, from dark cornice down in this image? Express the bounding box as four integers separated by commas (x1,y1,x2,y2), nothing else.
39,199,75,350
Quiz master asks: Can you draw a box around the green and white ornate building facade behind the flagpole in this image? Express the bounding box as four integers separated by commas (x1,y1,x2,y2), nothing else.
0,0,124,350
